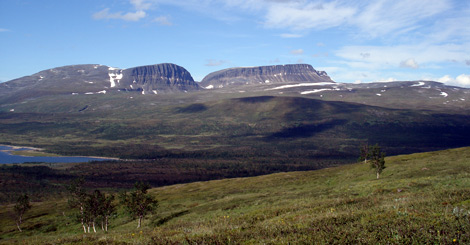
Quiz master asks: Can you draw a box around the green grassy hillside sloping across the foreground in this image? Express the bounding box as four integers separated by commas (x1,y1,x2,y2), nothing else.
0,148,470,244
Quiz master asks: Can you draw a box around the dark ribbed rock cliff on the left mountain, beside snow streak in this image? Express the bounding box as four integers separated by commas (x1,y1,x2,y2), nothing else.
118,63,200,94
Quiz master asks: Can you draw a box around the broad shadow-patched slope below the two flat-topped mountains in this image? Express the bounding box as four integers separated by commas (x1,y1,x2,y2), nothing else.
0,94,470,160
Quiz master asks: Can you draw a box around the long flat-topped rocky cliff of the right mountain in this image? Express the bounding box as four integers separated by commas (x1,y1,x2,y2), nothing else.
201,64,333,88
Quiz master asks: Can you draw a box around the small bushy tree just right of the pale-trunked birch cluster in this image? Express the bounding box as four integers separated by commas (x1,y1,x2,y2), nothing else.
121,181,158,228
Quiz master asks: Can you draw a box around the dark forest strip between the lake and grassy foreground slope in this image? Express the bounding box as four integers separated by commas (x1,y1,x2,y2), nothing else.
0,156,354,203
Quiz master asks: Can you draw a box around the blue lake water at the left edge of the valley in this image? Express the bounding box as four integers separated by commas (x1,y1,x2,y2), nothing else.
0,145,112,164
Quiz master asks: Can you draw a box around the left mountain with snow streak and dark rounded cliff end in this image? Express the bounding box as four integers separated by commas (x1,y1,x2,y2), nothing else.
0,63,200,102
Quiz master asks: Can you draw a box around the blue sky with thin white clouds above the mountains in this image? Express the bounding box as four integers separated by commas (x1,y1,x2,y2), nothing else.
0,0,470,87
